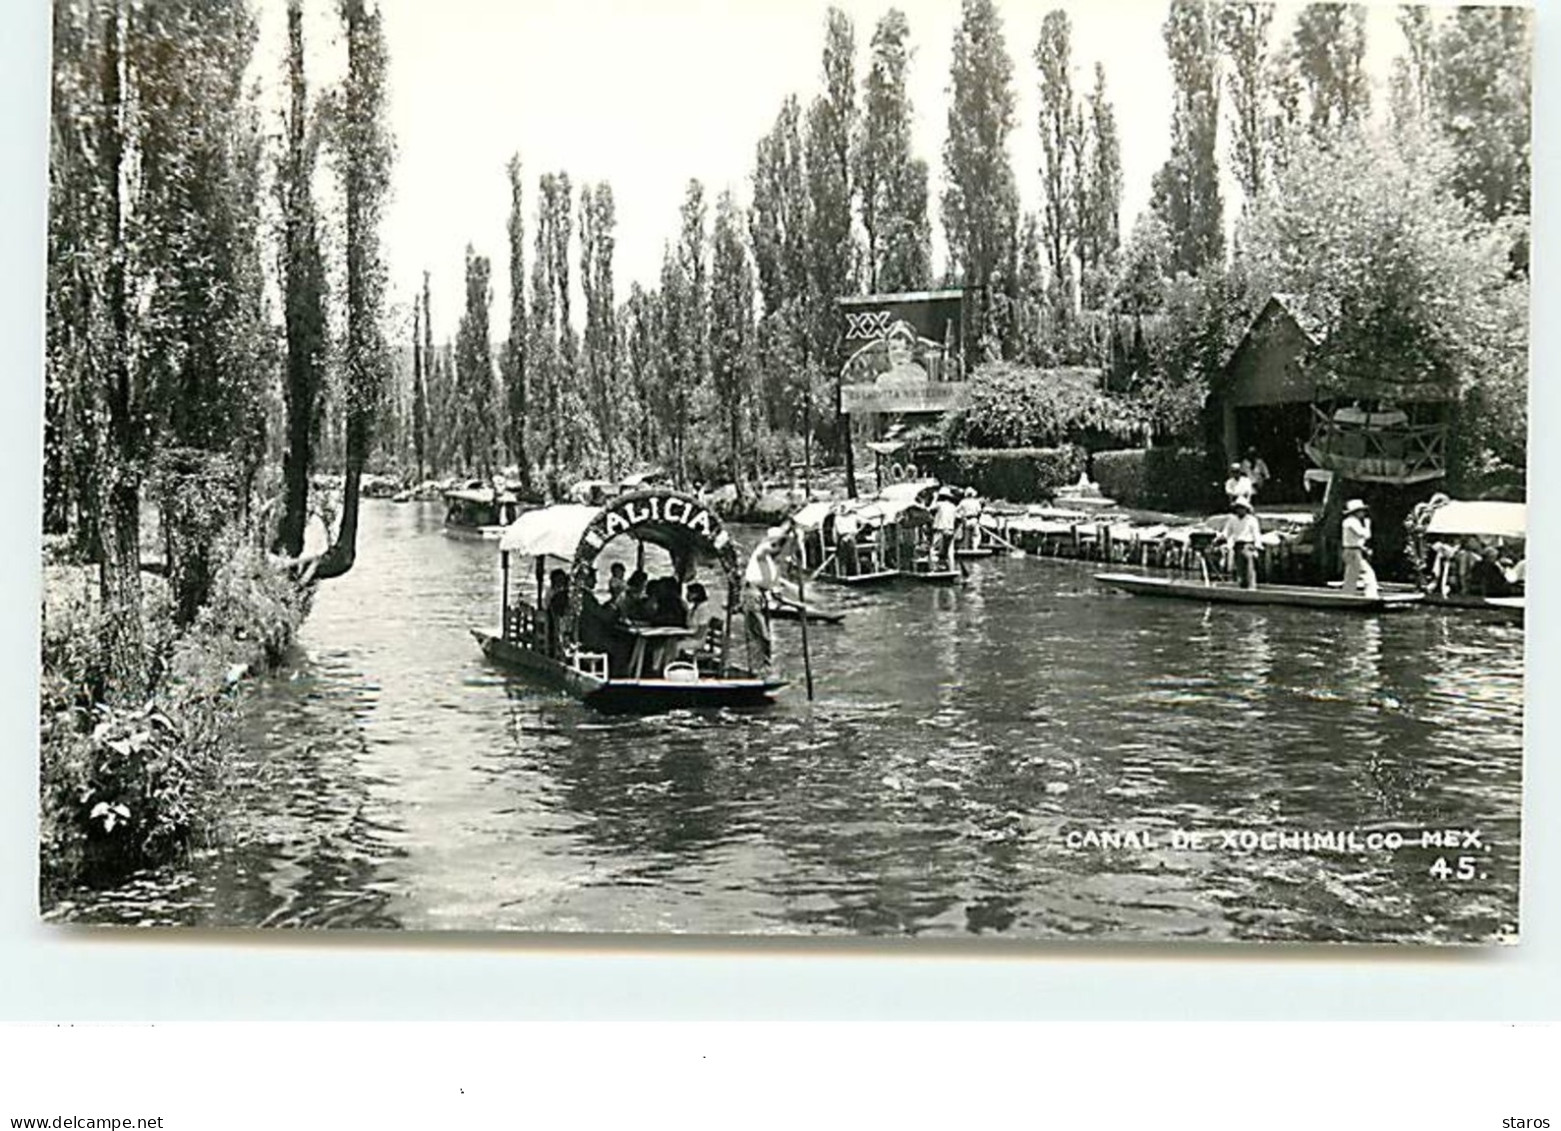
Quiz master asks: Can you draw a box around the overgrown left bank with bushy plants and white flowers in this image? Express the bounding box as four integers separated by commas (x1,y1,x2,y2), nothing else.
39,546,308,906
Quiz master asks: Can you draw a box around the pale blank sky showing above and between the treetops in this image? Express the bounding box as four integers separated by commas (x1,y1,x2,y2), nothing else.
258,0,1400,339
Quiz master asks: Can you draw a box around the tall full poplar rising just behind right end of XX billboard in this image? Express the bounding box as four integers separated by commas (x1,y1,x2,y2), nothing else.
943,0,1019,348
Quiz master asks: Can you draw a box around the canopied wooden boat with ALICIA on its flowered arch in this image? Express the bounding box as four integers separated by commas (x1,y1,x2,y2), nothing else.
471,488,785,713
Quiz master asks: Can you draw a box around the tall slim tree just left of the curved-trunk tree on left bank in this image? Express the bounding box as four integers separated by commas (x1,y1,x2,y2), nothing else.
276,0,327,557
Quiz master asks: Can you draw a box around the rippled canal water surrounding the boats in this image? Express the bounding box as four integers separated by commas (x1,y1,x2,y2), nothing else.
51,502,1524,942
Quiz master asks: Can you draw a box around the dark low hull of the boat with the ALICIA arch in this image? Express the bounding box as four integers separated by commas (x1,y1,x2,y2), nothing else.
471,629,785,714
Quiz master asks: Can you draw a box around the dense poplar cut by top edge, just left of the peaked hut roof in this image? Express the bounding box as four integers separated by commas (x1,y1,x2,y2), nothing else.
1150,0,1225,275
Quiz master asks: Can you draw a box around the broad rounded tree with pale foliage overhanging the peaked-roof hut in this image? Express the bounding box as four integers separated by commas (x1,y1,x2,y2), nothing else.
1243,127,1528,468
